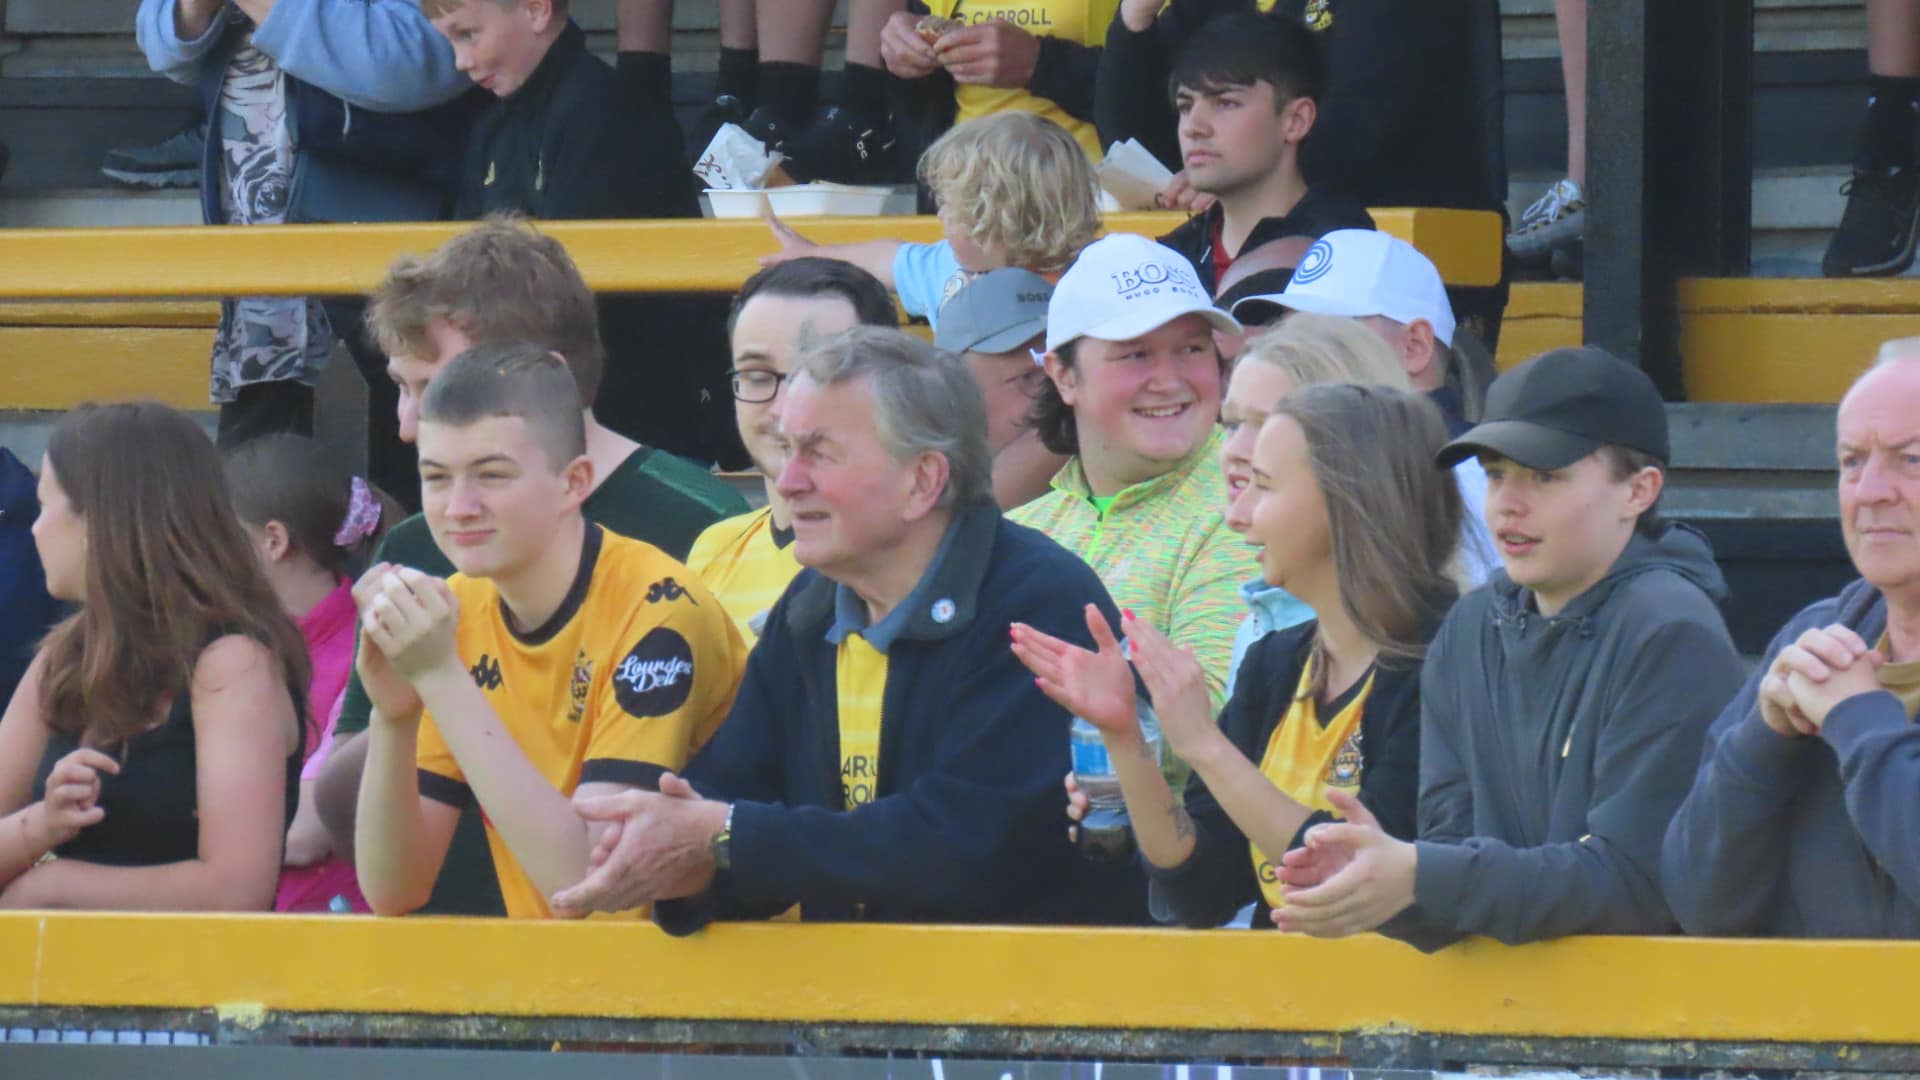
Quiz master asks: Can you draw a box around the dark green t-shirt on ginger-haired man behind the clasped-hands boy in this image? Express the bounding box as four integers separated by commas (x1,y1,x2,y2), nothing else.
334,446,749,915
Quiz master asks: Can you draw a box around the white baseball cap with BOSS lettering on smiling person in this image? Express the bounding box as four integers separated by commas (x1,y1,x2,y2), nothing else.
1046,233,1240,352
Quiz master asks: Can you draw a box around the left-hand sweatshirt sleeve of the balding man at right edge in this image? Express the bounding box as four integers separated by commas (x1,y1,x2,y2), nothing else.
1661,603,1820,936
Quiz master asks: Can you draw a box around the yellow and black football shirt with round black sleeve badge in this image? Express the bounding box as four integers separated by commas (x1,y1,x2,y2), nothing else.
419,525,747,919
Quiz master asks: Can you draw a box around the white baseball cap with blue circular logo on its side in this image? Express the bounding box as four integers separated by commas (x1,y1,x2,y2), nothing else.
1235,229,1453,346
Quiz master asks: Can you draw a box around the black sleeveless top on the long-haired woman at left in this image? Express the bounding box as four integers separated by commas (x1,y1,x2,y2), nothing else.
33,661,305,867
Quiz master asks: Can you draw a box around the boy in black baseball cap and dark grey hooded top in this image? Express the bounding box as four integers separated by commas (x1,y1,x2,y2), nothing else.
1273,348,1743,947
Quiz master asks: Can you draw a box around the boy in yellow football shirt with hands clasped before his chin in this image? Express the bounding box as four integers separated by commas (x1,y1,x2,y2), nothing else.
353,344,745,919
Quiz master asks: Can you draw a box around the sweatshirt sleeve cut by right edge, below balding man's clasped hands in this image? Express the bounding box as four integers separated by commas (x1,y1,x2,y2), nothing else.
1820,690,1920,903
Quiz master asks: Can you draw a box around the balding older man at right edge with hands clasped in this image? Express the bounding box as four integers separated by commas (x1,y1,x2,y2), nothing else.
1661,338,1920,938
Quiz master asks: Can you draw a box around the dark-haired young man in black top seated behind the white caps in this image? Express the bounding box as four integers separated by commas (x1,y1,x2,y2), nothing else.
1136,13,1373,294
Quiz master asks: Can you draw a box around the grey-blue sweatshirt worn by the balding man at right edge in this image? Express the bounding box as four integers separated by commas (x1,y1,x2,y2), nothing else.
1661,580,1920,938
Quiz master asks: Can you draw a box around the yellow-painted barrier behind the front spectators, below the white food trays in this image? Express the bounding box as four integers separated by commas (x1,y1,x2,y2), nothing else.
0,209,1501,409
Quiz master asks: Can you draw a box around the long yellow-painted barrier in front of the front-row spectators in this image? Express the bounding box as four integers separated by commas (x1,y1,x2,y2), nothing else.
0,913,1920,1043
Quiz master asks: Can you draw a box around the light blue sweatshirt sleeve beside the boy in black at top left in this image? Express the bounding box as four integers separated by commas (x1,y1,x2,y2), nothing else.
251,0,472,113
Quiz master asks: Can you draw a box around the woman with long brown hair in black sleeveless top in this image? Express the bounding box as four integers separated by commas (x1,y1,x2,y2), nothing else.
0,404,309,911
